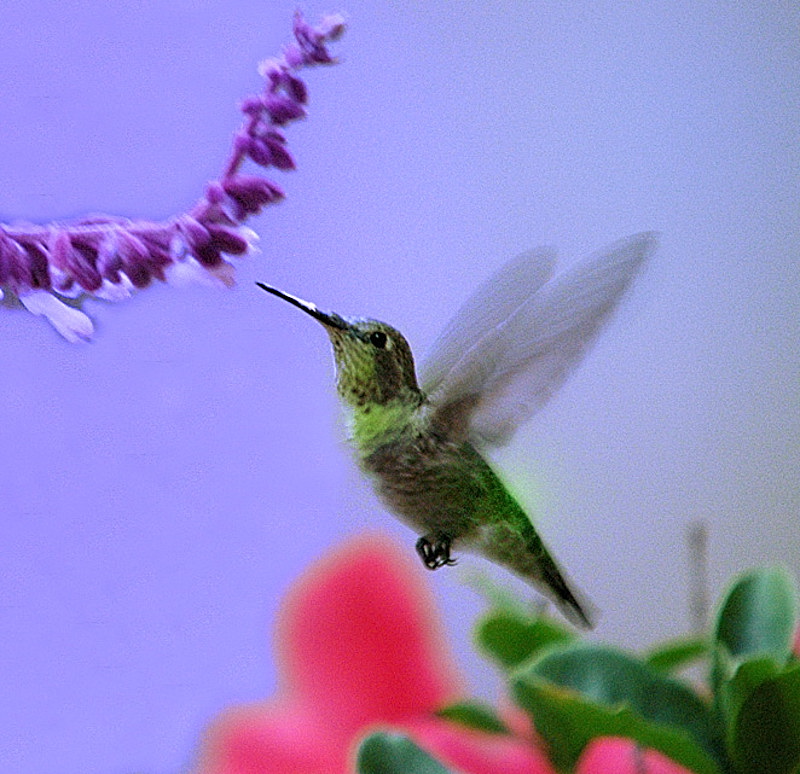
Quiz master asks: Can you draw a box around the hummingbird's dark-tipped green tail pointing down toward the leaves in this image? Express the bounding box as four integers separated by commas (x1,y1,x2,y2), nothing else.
480,513,594,629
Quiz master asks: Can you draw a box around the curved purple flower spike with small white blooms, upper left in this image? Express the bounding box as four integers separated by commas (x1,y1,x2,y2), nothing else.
0,12,344,341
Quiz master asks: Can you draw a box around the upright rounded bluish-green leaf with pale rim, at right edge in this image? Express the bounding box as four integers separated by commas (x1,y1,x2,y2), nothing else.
714,567,795,663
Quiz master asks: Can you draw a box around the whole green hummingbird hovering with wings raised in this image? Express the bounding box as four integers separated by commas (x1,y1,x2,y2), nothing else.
256,233,656,628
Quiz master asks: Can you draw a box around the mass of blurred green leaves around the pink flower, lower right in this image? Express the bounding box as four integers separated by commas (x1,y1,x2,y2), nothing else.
358,567,800,774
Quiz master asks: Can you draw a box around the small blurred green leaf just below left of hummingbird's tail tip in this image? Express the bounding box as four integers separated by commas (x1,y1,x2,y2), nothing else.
476,608,575,669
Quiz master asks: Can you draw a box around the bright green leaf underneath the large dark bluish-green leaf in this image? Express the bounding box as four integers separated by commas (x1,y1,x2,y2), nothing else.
512,675,720,774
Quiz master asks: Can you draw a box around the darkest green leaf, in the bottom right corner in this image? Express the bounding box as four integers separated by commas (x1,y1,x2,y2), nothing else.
730,665,800,774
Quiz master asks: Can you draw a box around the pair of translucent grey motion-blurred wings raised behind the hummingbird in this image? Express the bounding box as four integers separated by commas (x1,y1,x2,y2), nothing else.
422,233,656,446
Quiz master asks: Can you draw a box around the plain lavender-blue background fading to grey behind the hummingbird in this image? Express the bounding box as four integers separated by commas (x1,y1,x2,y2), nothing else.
0,0,800,774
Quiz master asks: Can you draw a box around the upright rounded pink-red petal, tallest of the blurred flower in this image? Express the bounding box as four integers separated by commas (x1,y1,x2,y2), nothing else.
278,535,463,738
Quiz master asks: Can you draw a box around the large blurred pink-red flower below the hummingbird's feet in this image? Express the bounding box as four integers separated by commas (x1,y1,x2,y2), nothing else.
196,535,554,774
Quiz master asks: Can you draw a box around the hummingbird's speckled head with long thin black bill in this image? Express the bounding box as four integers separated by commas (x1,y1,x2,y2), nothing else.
256,282,422,410
